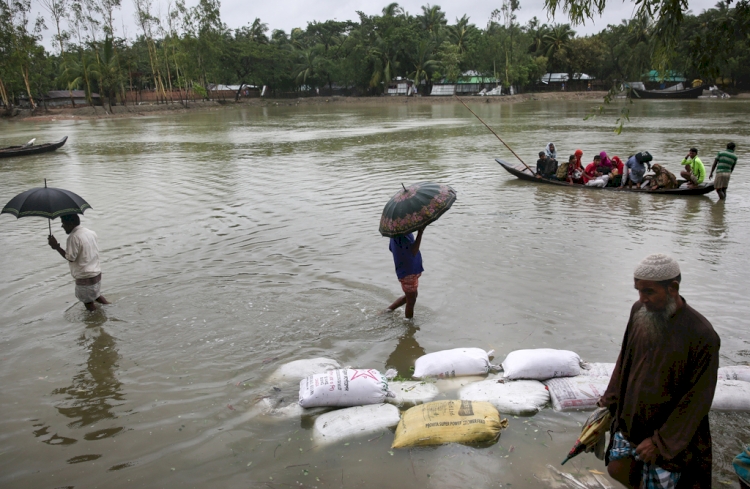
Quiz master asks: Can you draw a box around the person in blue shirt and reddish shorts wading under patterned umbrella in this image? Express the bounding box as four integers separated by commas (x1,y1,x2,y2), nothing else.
388,227,424,318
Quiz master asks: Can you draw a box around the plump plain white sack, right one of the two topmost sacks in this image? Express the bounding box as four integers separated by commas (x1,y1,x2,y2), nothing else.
503,348,581,380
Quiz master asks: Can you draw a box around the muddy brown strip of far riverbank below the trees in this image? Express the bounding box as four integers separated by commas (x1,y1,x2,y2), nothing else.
5,91,607,122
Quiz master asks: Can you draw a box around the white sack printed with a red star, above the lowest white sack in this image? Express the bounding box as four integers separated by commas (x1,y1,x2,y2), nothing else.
299,368,393,408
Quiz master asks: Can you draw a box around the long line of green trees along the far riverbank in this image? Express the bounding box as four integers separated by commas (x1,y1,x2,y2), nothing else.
0,0,750,108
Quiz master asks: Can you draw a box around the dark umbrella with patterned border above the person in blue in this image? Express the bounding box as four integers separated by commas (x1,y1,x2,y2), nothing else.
380,182,456,238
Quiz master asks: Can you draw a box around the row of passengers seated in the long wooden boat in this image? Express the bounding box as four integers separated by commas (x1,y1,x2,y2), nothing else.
536,143,736,190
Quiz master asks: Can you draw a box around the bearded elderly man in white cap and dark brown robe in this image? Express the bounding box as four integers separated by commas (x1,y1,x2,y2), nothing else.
599,254,720,489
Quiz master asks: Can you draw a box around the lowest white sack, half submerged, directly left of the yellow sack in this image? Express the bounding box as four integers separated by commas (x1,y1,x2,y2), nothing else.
313,404,401,444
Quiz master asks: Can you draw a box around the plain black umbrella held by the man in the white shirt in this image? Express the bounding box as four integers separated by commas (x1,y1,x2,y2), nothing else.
0,179,92,234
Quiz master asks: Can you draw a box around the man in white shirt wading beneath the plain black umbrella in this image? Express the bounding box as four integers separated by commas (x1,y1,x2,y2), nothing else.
47,214,109,311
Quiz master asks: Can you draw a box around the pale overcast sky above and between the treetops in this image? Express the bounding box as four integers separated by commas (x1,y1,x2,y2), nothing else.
39,0,717,48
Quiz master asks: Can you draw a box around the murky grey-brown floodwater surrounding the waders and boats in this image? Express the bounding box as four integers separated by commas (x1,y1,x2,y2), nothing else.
0,99,750,488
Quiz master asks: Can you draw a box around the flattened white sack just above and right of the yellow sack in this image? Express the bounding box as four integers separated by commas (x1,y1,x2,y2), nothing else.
458,380,550,416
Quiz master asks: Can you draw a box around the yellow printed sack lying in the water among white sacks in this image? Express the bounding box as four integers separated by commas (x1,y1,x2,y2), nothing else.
392,400,508,448
